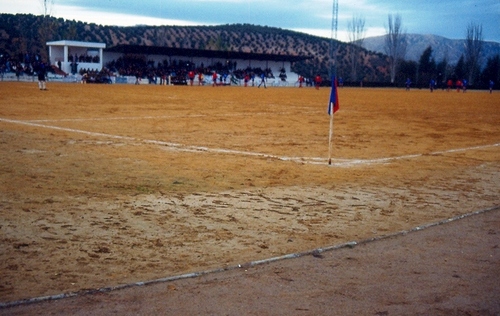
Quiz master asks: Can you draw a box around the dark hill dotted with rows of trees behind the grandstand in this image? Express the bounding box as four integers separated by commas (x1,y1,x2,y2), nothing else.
0,14,388,82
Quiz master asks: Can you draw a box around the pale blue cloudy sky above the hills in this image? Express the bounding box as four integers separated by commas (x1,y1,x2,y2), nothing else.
0,0,500,42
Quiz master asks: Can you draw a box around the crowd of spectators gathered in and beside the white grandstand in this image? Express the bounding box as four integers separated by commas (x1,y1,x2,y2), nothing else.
0,52,287,86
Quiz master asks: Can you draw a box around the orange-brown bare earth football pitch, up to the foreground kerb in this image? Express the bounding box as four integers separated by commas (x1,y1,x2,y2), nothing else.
0,82,500,314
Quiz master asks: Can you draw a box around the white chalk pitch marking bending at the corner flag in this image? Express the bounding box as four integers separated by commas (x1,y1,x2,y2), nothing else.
0,118,500,167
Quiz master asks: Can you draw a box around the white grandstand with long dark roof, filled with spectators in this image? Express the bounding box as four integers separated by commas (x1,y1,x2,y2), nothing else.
0,40,311,86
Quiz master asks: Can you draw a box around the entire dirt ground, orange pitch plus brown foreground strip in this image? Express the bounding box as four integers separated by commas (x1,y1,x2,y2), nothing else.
0,82,500,315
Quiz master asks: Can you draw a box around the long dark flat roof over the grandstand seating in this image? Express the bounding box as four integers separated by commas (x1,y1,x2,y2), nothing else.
106,45,312,62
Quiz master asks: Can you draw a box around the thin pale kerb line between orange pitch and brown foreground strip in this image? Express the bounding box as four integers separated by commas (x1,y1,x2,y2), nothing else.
0,205,500,309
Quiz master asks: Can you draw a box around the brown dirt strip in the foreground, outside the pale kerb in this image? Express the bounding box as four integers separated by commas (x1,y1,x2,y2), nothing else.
6,209,500,315
